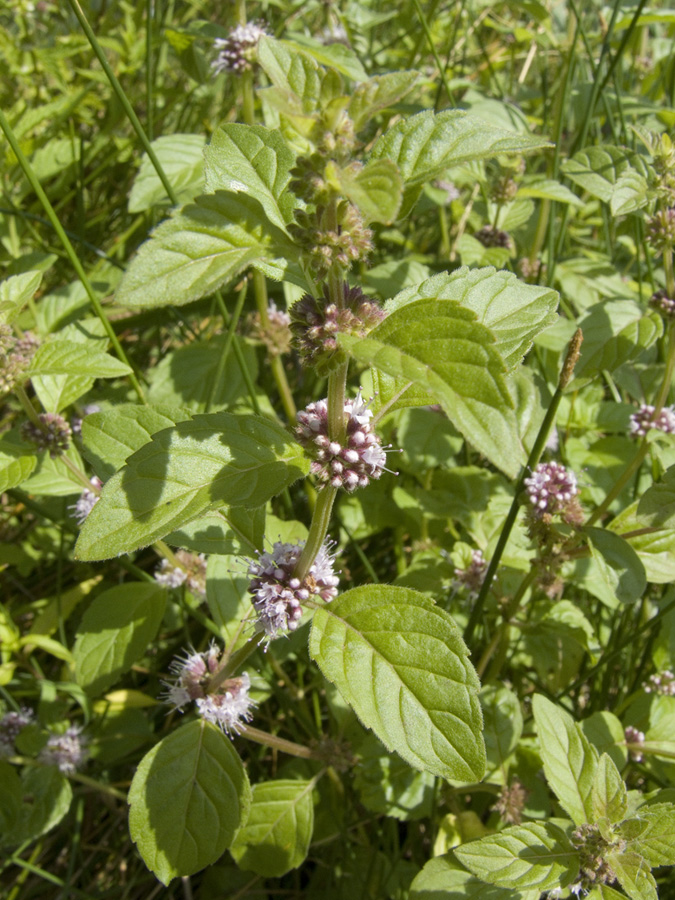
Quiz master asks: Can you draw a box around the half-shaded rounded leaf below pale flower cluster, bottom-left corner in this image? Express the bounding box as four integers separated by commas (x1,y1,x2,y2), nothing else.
11,766,73,844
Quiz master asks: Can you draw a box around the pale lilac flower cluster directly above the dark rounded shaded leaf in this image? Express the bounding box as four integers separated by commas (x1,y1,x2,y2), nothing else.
165,644,256,735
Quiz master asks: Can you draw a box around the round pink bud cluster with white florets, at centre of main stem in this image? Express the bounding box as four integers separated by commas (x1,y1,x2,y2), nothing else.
296,391,387,493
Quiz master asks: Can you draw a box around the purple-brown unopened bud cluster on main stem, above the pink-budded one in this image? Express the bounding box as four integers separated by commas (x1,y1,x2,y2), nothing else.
290,283,385,375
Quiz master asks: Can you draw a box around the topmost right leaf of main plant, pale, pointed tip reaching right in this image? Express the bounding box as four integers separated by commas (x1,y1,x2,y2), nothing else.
371,109,548,185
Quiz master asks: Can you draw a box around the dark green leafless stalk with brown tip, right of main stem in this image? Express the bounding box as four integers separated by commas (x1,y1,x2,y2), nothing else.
464,329,582,644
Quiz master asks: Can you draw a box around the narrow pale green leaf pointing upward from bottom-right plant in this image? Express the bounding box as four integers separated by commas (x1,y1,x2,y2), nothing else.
532,694,598,825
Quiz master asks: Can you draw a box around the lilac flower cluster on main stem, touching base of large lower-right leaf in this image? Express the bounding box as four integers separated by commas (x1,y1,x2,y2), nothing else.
248,541,340,640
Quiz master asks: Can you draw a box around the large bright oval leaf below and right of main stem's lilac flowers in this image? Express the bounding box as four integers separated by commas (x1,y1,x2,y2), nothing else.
309,585,485,781
